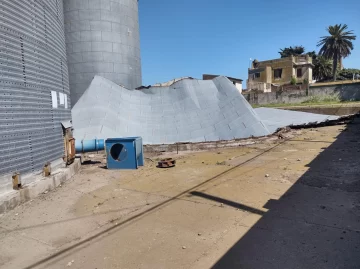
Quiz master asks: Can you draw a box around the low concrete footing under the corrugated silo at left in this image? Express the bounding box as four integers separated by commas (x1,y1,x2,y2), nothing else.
0,159,81,214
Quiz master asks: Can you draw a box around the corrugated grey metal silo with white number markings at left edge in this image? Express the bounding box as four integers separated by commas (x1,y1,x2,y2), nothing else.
0,0,71,188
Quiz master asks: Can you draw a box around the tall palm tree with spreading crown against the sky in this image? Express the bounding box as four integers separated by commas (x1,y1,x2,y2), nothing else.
317,24,356,81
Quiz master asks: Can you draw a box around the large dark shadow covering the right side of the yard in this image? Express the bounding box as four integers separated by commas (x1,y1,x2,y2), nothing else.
213,118,360,269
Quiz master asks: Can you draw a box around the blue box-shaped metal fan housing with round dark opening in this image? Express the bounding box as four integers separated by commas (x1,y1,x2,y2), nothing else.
105,137,144,169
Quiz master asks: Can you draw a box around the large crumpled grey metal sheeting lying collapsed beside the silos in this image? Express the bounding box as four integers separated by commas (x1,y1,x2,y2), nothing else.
72,76,270,144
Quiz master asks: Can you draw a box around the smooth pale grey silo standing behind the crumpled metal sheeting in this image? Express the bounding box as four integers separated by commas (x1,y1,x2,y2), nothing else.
64,0,141,105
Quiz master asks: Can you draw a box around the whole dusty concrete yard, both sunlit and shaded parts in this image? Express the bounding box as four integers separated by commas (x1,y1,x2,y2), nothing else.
0,120,360,269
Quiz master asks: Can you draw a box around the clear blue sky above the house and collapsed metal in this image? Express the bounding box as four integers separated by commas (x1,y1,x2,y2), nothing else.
139,0,360,85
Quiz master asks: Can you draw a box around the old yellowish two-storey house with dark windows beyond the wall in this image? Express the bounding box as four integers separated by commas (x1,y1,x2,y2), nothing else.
247,55,314,92
